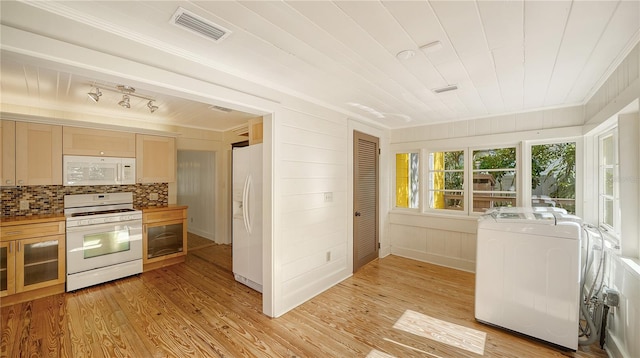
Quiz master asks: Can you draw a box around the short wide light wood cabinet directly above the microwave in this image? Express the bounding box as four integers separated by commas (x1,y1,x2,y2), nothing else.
62,127,136,158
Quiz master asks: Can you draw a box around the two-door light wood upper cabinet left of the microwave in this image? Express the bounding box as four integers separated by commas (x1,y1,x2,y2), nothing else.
0,121,62,186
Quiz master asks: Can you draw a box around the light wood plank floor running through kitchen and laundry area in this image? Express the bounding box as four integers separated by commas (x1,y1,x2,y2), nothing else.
0,245,606,357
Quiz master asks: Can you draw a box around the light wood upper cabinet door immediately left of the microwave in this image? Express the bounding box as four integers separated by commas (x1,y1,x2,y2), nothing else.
15,122,62,185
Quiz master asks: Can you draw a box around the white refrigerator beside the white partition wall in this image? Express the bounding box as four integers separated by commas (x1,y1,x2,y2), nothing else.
231,144,262,292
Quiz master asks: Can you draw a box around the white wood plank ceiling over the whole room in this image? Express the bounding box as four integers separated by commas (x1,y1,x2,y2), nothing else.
0,0,640,130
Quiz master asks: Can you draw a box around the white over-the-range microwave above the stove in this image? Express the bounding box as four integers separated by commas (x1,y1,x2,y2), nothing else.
62,155,136,186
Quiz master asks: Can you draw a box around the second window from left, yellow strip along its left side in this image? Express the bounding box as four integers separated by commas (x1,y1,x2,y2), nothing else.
429,150,464,210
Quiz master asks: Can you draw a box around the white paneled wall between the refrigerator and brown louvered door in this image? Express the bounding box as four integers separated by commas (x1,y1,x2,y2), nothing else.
273,107,351,316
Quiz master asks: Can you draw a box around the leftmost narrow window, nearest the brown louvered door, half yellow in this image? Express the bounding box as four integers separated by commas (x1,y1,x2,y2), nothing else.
396,153,420,209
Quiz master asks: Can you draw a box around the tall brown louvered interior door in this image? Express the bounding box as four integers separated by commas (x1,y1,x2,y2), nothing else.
353,131,379,272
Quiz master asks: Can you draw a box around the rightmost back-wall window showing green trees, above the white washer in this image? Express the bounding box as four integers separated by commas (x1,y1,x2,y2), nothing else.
531,142,576,214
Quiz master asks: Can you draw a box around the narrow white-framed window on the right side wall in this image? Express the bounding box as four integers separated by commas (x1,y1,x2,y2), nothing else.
598,132,619,233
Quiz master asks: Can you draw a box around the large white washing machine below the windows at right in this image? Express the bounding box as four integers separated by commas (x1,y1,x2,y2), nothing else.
475,208,582,350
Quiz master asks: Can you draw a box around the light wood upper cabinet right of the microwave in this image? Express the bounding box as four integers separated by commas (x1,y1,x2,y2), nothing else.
136,134,176,183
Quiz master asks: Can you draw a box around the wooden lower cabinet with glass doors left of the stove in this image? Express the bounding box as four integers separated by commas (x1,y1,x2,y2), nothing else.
0,221,66,306
